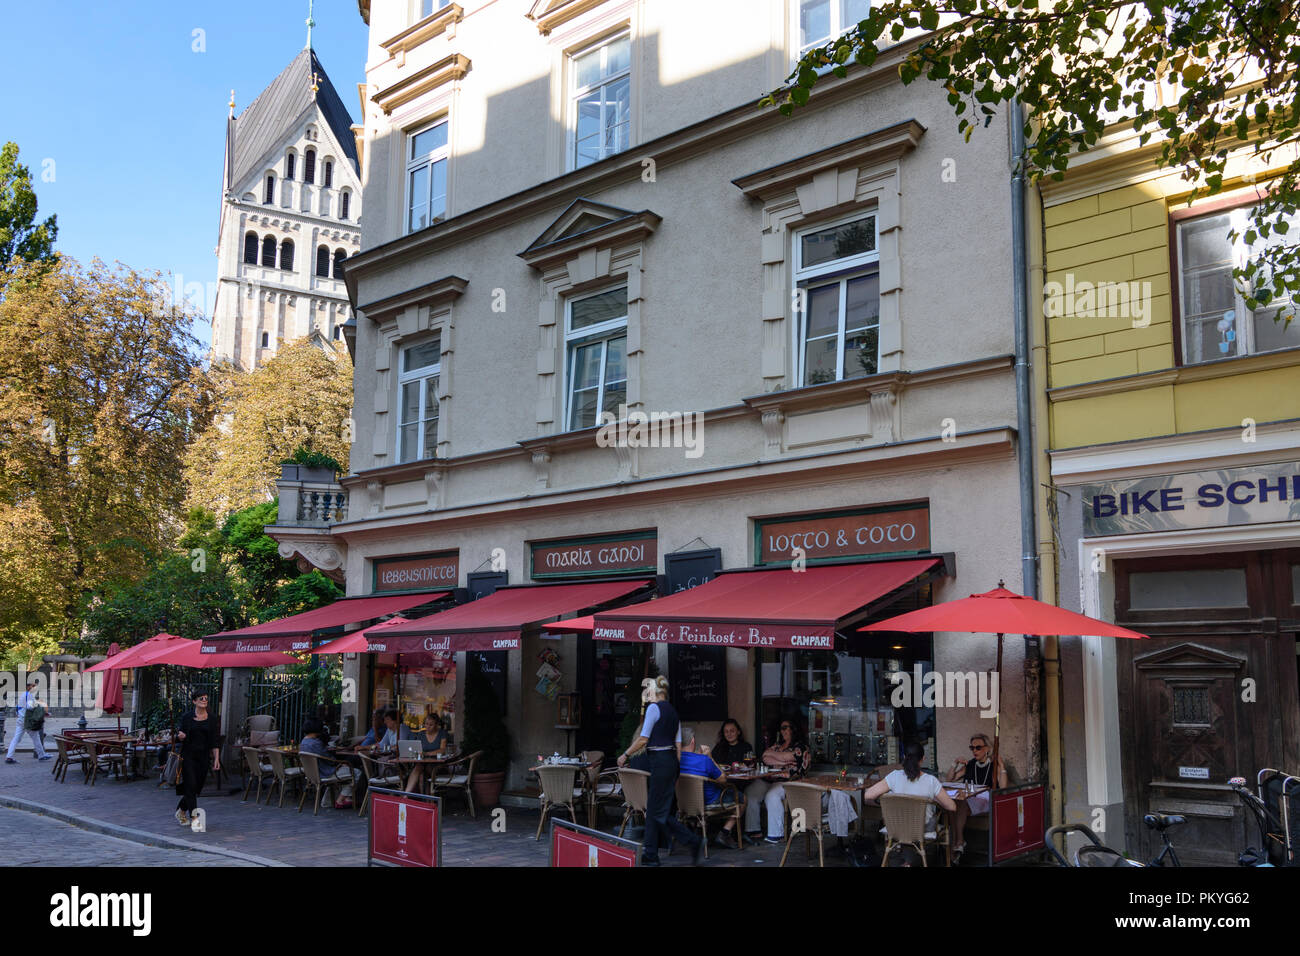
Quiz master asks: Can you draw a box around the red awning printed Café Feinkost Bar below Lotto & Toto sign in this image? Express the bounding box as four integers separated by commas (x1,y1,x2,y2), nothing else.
592,558,940,649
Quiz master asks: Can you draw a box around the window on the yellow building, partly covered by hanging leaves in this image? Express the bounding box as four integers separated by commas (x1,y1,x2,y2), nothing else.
1174,206,1300,365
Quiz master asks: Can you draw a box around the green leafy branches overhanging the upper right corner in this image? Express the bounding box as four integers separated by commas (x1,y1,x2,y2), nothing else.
763,0,1300,321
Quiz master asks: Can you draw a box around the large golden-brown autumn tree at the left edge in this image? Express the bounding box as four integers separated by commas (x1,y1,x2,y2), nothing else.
0,256,209,641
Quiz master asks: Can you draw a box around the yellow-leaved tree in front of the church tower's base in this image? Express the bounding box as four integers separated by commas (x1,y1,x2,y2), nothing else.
185,339,352,520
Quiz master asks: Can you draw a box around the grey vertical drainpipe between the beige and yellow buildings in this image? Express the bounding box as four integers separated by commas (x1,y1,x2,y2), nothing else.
1010,99,1061,818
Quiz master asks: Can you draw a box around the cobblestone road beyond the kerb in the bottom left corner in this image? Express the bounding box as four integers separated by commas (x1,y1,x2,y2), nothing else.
0,806,254,866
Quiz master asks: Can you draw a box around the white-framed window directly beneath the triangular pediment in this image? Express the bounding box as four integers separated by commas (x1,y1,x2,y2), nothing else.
564,286,628,431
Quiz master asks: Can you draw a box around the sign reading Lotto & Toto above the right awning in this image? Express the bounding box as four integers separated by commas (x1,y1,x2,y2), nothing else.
755,502,930,564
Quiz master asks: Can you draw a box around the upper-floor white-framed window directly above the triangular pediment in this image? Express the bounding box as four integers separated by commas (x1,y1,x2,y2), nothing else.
568,33,632,169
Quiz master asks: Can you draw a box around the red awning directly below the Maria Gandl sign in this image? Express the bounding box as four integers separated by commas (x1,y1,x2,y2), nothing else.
369,581,650,654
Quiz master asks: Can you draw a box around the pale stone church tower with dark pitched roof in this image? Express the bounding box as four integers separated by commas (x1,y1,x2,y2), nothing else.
212,41,361,371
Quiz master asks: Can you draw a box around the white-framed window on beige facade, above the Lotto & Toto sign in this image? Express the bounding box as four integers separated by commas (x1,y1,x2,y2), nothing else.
793,212,880,386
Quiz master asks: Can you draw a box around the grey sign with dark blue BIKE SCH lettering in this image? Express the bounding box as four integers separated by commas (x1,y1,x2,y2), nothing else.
1083,462,1300,537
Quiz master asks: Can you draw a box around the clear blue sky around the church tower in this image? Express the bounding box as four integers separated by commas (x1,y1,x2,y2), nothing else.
0,0,367,350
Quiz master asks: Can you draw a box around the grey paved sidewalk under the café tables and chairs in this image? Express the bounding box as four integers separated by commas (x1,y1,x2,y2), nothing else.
0,754,868,866
